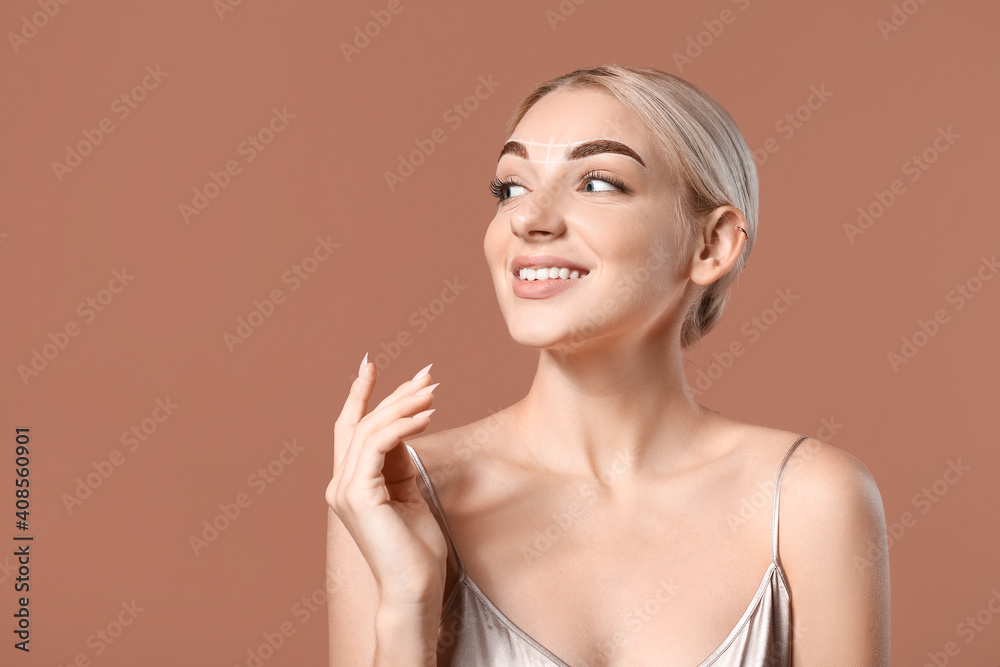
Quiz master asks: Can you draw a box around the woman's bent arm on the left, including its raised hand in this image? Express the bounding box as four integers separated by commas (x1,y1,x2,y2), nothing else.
325,362,448,667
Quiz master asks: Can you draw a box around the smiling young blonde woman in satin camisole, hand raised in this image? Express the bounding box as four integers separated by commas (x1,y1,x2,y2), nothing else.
326,66,889,667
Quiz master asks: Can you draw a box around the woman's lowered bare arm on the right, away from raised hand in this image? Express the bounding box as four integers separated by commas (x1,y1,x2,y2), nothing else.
778,441,890,667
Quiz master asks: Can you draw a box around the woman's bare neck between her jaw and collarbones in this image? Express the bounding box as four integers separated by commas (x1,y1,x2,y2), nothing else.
512,346,715,482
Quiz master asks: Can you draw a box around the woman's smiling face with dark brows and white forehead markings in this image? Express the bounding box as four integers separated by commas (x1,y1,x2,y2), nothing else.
483,89,690,351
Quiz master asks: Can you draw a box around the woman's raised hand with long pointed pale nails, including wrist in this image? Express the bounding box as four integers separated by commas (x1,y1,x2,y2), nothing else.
326,354,448,608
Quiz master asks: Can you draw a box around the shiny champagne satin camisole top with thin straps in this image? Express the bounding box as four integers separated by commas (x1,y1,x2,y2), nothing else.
406,436,808,667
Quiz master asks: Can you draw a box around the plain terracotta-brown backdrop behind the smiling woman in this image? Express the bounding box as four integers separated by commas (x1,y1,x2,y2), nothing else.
0,0,1000,666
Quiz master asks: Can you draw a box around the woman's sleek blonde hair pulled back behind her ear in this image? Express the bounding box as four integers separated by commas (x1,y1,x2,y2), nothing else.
507,65,758,348
